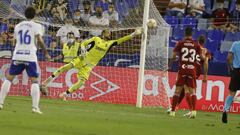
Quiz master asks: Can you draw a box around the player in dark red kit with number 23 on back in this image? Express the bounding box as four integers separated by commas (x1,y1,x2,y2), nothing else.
170,27,204,118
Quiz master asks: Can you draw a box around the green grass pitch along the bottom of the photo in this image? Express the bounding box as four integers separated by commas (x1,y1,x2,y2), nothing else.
0,97,240,135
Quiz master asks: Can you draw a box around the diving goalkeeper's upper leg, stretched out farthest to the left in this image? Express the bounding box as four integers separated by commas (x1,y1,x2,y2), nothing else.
42,63,74,86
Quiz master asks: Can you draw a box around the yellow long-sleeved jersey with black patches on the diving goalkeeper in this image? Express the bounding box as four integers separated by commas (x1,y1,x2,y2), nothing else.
81,35,132,66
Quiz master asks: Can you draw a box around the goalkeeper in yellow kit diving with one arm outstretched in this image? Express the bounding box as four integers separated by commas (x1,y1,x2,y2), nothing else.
42,28,143,100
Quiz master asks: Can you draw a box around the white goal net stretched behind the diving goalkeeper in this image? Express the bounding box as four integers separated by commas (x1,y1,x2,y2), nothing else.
0,0,170,107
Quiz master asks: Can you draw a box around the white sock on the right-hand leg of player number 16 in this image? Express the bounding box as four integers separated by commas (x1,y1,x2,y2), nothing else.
31,83,40,109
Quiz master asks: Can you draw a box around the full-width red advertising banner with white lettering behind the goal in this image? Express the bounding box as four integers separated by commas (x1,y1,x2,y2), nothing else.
0,59,240,113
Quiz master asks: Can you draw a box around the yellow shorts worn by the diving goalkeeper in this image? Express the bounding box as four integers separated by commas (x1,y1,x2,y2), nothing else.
70,57,94,80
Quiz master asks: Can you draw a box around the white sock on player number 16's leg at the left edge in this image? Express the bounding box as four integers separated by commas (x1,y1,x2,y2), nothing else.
0,80,11,104
